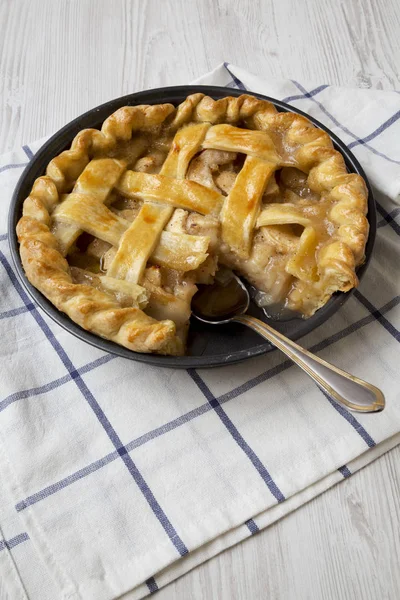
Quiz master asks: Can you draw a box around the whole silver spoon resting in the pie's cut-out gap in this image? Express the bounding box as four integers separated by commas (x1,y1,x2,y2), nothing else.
192,274,385,412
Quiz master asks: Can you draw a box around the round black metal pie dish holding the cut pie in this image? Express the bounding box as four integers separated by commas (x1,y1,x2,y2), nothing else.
8,85,376,369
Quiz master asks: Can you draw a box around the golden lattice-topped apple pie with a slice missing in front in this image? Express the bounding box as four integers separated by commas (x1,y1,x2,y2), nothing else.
18,95,368,354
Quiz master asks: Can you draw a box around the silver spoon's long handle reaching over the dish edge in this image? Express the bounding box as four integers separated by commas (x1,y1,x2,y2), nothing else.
232,315,385,412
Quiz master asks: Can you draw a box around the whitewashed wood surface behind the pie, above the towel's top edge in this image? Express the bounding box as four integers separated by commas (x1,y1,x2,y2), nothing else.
0,0,400,152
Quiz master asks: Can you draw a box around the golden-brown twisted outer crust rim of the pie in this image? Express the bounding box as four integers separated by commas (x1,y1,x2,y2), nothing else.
17,94,368,354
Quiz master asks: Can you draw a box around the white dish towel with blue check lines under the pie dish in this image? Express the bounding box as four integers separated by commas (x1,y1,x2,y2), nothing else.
0,65,400,600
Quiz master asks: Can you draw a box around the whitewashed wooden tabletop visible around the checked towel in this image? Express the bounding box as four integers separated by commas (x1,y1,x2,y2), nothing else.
0,0,400,600
